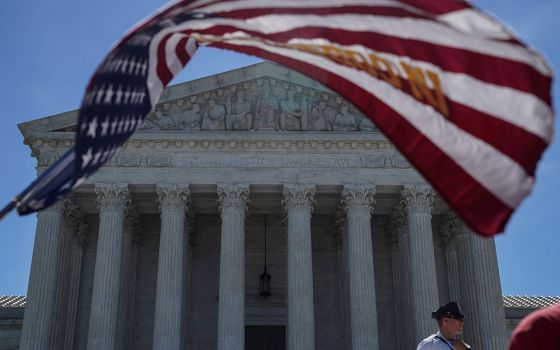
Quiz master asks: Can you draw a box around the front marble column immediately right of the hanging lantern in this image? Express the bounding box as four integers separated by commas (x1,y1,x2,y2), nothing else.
283,184,316,350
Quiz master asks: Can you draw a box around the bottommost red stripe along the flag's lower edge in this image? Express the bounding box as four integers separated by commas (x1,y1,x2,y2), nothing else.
210,43,513,236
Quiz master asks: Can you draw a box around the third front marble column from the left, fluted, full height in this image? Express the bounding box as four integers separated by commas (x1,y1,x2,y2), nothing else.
153,184,190,350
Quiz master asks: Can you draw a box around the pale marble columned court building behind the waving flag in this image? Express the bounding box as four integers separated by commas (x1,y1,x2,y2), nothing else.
19,62,508,350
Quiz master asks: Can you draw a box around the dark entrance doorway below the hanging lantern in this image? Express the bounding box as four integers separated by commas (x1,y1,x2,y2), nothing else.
245,326,286,350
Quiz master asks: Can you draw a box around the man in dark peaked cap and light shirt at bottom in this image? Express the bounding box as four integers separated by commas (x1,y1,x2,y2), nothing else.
416,301,471,350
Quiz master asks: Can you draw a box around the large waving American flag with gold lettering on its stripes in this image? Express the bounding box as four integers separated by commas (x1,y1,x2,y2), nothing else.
0,0,554,235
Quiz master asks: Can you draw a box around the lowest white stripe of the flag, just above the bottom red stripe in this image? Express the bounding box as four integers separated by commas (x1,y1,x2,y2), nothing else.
222,40,533,208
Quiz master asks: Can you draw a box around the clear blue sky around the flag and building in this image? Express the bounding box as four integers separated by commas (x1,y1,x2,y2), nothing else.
0,0,560,296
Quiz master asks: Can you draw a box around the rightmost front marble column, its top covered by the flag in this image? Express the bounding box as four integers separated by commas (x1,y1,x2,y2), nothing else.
456,220,508,350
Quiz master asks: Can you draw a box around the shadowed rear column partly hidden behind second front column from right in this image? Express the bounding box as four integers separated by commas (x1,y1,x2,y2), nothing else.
391,205,418,349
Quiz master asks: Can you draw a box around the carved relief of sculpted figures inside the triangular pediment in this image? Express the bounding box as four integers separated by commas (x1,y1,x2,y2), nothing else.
140,78,376,132
